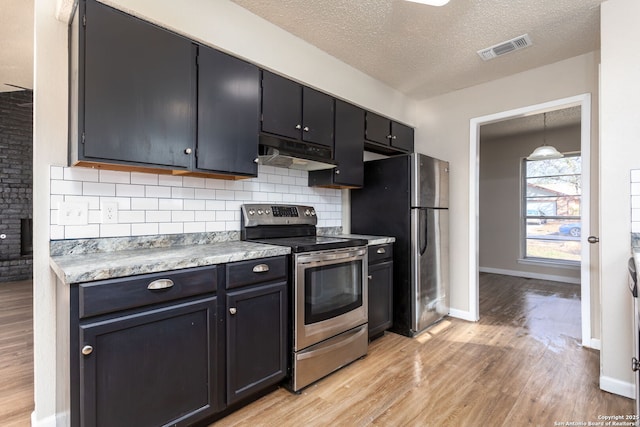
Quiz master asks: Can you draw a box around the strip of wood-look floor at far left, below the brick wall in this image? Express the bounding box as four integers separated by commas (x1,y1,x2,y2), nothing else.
0,280,33,427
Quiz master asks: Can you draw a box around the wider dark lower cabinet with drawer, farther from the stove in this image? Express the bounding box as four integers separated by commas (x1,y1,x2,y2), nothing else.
71,267,224,426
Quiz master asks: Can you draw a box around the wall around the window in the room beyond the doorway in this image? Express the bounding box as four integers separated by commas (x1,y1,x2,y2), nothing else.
478,125,580,283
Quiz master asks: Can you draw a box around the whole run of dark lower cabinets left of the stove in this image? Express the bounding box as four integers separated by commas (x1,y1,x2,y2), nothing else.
70,256,288,427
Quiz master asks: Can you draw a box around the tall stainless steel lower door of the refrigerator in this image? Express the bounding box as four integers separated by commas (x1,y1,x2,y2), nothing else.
411,209,449,334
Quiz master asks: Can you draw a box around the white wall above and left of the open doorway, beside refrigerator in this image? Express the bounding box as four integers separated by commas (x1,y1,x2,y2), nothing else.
416,53,599,313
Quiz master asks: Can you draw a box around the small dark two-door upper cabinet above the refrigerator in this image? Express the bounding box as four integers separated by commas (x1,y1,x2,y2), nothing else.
365,111,414,154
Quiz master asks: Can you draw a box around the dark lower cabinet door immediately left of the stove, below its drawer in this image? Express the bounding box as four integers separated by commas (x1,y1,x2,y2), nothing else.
227,282,287,404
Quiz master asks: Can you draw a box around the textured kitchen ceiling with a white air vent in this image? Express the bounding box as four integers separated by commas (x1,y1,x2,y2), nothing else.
232,0,603,99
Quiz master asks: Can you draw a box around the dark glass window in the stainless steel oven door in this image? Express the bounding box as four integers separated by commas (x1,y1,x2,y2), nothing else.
304,260,362,325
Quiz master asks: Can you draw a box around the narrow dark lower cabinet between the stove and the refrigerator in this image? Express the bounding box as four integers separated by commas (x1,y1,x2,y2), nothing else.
368,243,393,340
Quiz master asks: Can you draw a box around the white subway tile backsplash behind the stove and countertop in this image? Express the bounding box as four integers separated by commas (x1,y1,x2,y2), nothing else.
50,165,342,240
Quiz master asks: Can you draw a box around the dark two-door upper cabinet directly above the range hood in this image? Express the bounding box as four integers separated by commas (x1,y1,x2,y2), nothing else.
262,71,334,147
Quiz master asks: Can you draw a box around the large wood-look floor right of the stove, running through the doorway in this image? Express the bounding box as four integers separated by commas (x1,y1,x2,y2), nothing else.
212,274,633,427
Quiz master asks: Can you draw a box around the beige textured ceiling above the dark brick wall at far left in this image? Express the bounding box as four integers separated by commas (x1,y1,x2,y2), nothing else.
0,0,33,92
